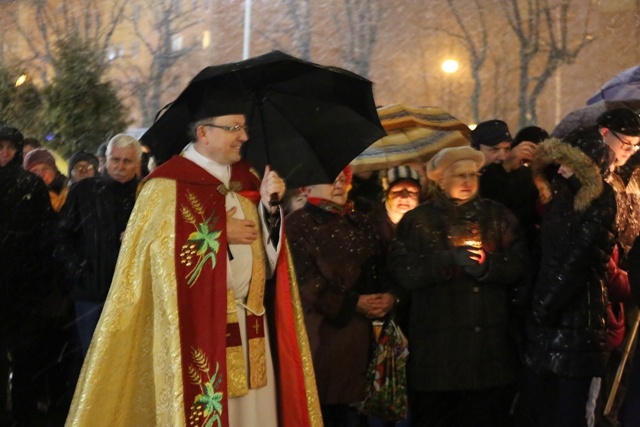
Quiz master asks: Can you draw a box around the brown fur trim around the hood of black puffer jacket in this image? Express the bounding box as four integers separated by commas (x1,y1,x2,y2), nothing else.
531,138,604,212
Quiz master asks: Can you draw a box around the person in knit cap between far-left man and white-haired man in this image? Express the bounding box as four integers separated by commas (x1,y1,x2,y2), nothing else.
22,148,68,212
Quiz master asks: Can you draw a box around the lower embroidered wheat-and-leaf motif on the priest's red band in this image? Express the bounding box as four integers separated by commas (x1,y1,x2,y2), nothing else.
189,348,223,427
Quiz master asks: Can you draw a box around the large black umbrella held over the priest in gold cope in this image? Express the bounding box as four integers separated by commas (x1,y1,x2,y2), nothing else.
140,51,385,188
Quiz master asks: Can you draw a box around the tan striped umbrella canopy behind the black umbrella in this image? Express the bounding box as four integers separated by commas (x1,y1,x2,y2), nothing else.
351,104,471,173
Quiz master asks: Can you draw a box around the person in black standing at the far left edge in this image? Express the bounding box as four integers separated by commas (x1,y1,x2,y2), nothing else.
0,126,53,425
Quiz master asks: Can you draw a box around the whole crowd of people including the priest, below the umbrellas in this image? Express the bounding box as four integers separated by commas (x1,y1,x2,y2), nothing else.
0,101,640,427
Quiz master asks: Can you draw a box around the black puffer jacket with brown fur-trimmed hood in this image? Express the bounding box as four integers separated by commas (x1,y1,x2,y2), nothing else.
525,139,616,377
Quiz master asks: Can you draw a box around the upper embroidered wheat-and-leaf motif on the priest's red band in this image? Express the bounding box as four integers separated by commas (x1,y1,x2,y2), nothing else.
180,192,221,287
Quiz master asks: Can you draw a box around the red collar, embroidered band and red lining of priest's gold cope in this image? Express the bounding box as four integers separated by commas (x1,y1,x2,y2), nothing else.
147,156,321,427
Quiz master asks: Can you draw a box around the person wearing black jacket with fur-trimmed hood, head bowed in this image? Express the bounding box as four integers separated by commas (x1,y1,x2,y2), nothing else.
519,129,616,427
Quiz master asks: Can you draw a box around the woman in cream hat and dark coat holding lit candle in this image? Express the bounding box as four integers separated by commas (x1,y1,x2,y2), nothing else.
389,147,526,427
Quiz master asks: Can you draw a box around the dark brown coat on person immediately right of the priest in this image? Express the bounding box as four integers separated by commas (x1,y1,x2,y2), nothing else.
285,203,380,405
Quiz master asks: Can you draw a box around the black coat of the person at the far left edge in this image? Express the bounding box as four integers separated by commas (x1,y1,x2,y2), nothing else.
0,159,53,329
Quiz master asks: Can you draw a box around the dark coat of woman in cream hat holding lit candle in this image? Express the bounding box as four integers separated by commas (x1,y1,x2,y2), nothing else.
388,192,526,392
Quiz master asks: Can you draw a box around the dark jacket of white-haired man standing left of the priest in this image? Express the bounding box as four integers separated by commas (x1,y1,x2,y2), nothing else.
55,173,138,302
